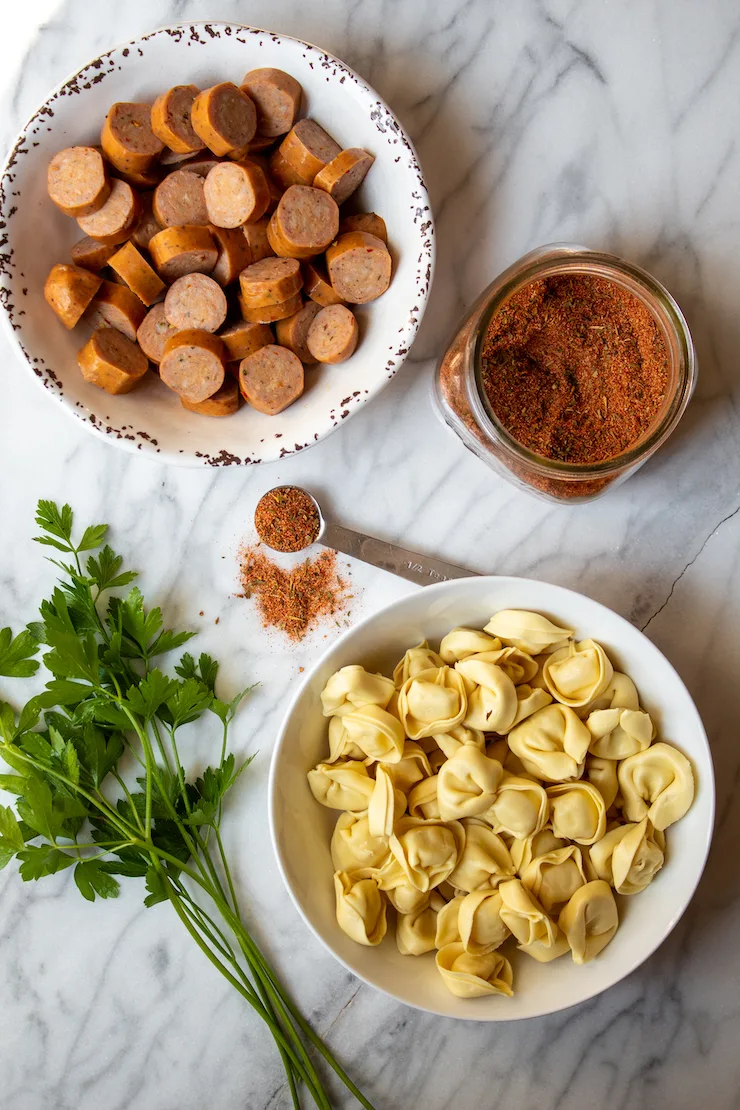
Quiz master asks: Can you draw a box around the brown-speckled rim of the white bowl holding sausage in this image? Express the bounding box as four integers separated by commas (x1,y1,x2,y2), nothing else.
0,20,436,467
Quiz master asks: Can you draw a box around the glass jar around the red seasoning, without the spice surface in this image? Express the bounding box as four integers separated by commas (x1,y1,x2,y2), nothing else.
435,243,697,505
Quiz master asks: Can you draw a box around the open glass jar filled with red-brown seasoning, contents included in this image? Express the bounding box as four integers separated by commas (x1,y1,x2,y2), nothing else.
435,243,697,504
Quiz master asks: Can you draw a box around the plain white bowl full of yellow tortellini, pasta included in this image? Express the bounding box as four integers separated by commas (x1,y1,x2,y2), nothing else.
270,577,714,1021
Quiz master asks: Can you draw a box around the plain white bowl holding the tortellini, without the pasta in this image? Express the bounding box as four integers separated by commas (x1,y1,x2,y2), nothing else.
270,577,714,1021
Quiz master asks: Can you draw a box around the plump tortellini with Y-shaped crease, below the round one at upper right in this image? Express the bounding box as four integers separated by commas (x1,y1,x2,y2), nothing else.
508,703,591,783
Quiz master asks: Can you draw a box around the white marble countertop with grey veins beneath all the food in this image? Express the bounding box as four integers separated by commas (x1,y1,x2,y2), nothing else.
0,0,740,1110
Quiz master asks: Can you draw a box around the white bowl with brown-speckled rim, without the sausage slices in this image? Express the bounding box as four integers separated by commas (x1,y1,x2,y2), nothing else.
0,22,434,466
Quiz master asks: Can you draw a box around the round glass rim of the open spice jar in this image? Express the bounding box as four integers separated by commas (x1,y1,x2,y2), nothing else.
468,243,697,482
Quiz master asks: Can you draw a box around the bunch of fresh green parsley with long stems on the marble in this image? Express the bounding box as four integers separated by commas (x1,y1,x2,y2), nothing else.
0,501,372,1110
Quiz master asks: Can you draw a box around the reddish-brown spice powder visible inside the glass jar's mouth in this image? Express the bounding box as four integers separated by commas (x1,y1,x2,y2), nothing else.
481,274,669,463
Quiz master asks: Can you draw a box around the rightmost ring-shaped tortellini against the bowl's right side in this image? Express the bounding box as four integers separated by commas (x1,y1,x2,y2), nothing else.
617,743,693,831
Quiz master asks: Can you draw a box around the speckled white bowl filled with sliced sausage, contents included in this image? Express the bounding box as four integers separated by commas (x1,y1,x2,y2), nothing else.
0,23,434,466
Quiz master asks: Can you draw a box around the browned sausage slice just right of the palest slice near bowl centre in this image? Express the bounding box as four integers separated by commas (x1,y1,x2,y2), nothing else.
267,185,339,259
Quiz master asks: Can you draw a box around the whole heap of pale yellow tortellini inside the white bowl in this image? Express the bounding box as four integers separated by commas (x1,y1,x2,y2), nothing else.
307,609,695,1005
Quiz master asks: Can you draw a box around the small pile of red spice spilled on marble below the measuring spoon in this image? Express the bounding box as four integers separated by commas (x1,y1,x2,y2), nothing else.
240,547,353,640
